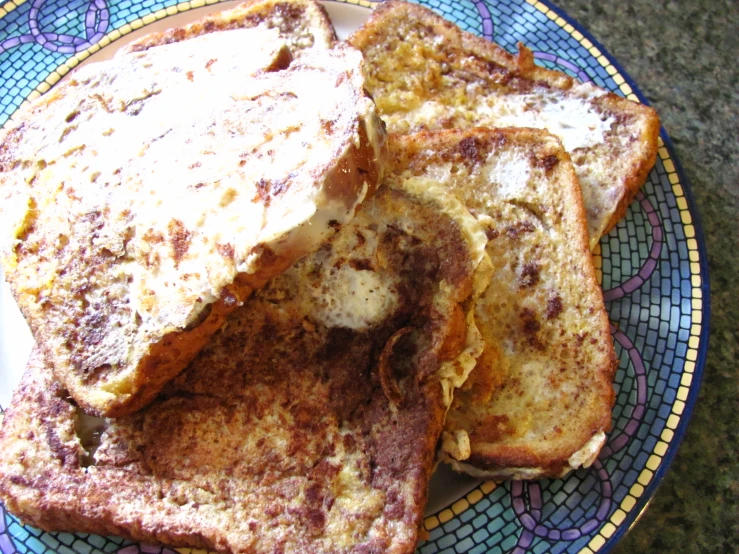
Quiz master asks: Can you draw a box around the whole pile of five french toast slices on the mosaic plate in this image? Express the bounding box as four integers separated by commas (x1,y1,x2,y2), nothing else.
0,0,659,553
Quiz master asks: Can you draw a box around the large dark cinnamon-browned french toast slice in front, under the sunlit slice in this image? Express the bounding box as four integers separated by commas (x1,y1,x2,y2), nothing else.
0,178,489,554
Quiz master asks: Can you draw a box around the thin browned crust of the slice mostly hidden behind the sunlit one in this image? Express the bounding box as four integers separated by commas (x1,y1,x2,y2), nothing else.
124,0,338,52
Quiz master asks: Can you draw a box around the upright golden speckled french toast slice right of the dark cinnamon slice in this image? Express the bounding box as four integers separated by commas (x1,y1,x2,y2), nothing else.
389,128,616,479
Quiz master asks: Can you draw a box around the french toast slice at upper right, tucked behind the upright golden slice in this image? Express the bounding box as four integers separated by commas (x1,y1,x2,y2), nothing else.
349,0,660,249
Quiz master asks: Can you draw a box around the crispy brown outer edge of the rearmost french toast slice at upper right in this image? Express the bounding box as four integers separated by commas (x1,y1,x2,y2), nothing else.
348,0,660,235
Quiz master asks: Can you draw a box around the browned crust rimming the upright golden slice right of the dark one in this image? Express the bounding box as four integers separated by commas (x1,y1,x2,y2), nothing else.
388,127,618,478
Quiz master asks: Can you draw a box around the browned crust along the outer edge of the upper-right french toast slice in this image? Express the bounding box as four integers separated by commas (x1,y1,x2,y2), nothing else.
348,0,660,244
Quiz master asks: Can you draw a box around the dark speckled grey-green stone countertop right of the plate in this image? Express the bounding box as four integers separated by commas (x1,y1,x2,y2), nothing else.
554,0,739,554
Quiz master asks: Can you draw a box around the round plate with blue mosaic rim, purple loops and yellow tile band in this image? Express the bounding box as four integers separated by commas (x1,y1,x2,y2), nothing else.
0,0,710,554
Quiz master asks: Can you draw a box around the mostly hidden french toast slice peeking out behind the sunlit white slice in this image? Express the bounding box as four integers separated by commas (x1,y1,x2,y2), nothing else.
119,0,337,56
